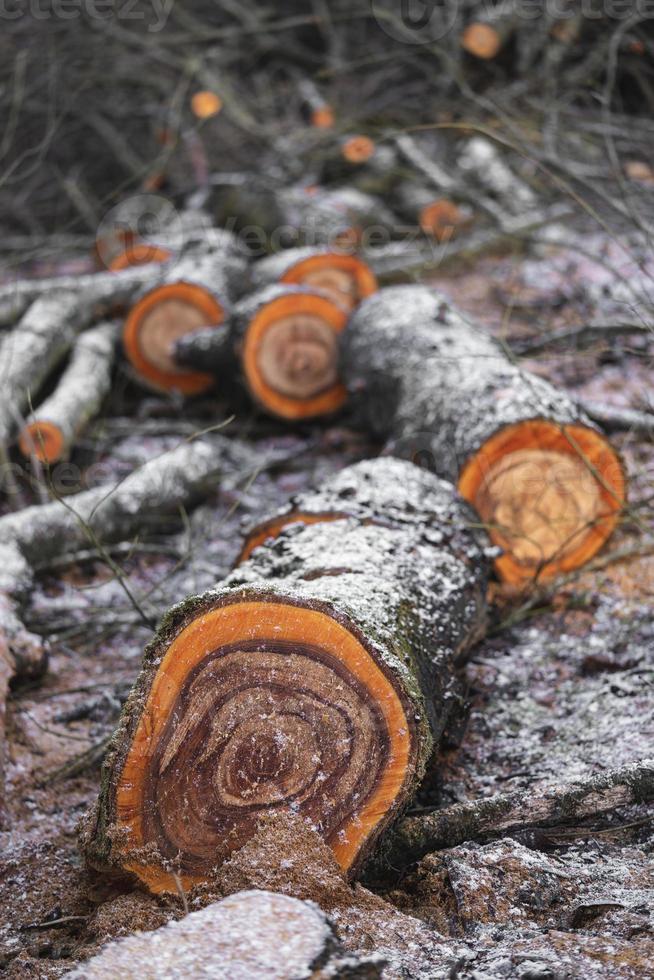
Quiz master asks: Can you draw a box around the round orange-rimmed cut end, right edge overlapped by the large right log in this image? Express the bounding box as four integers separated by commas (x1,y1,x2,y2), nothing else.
242,292,347,419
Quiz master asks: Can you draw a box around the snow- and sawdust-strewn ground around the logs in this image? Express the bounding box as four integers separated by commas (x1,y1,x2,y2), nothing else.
0,224,654,980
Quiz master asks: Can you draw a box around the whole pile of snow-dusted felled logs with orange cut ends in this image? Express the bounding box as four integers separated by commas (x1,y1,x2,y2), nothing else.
0,128,636,904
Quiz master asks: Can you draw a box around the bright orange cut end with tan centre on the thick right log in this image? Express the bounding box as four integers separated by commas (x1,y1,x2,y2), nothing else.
458,419,626,585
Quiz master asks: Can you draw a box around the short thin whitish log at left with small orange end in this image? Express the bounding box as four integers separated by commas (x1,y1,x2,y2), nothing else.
18,323,119,463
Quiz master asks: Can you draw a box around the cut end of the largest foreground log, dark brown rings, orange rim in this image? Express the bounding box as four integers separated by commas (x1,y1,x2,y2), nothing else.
113,598,415,893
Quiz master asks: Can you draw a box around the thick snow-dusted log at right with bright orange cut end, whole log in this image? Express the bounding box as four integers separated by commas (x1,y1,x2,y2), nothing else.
341,286,625,584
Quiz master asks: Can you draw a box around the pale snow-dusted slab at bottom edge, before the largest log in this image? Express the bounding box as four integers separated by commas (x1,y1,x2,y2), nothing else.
68,889,385,980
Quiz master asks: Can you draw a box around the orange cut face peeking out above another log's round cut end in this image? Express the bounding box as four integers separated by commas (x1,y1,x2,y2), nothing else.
281,252,379,310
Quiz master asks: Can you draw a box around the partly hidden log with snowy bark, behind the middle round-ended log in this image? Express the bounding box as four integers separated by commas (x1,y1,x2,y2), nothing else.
252,248,378,310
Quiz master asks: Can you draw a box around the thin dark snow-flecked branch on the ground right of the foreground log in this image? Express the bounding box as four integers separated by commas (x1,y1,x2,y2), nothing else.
386,759,654,866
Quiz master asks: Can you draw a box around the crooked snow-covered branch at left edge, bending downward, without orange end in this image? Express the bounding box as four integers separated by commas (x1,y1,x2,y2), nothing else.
0,436,255,812
